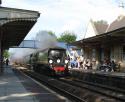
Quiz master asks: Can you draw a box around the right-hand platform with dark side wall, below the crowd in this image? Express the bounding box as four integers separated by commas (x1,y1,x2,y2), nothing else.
70,68,125,90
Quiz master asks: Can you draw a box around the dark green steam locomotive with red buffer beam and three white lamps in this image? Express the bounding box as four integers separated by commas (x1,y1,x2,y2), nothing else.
25,47,69,75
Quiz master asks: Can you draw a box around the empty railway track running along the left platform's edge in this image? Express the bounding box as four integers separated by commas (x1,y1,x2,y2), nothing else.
18,70,87,102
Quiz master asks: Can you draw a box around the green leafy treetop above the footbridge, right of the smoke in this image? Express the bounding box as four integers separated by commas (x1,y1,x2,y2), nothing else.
57,31,77,43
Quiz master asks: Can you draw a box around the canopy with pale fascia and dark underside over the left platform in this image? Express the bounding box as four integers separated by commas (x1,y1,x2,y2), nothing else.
0,7,40,49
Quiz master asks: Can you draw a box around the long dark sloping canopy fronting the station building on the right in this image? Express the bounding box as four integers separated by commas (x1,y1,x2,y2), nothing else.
72,27,125,47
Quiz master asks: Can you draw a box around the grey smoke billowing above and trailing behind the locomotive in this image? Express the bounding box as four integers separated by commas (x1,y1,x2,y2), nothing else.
9,31,57,63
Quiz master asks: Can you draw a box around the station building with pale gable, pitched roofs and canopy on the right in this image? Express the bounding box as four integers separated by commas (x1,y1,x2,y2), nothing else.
73,11,125,71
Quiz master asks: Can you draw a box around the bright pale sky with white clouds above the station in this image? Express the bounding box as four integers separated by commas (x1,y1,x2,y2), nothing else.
2,0,125,40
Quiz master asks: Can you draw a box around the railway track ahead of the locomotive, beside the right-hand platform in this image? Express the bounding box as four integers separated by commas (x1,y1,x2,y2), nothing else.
59,78,125,102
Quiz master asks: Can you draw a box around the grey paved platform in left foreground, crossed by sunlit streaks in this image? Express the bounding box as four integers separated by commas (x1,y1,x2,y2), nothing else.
0,66,69,102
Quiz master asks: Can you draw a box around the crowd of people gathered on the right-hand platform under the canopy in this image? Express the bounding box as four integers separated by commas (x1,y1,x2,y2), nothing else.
69,55,119,72
